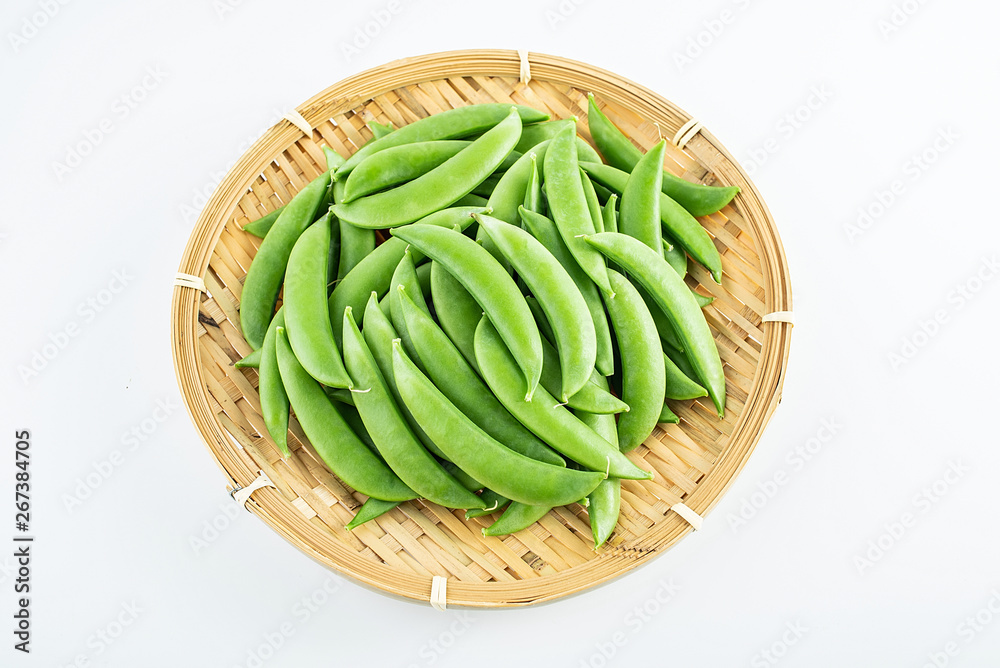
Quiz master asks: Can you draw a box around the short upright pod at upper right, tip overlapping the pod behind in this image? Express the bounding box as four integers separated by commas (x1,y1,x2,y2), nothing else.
618,140,664,253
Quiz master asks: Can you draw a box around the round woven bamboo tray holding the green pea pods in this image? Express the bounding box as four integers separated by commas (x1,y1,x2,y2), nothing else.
171,50,791,607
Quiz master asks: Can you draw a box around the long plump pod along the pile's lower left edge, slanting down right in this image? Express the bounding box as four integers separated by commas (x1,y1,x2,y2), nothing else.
277,327,416,501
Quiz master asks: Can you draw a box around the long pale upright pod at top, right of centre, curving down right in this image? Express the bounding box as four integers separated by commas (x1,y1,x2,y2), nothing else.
543,123,611,292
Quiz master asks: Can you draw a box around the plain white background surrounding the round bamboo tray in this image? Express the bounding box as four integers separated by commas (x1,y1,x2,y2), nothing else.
0,0,1000,668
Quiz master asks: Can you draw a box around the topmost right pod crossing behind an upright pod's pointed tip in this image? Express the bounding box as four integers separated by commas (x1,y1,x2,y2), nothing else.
587,95,740,216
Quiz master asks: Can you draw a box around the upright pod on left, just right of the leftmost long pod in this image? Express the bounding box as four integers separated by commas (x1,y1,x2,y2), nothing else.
283,216,352,387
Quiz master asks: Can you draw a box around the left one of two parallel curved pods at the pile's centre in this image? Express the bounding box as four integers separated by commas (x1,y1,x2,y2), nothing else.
392,225,542,400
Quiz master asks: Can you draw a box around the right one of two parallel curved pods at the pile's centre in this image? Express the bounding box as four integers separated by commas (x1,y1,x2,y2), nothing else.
475,214,597,401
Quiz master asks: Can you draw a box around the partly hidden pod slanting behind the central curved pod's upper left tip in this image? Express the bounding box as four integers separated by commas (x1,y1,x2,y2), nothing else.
329,207,482,348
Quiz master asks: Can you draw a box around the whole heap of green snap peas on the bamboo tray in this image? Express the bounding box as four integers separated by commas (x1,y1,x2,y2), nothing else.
237,96,738,549
